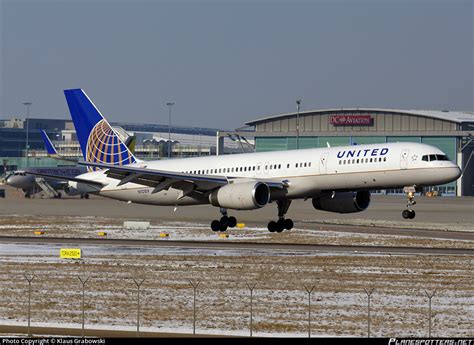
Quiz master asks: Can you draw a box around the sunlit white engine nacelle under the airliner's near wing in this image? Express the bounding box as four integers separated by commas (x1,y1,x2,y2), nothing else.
209,182,270,210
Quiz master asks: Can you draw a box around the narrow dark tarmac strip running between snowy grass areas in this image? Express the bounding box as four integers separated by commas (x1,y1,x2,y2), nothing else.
0,236,474,255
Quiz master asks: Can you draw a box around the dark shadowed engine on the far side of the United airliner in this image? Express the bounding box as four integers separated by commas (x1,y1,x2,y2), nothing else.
313,191,370,213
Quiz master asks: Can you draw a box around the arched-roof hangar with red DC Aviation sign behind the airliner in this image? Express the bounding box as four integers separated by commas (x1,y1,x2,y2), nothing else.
217,108,474,196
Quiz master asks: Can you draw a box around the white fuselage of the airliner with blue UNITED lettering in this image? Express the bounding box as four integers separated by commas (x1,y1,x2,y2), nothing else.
69,143,461,205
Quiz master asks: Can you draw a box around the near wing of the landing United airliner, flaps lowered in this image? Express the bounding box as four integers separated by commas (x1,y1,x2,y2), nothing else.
79,162,287,197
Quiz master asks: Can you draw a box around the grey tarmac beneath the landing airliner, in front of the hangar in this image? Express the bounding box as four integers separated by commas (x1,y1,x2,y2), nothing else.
0,186,474,226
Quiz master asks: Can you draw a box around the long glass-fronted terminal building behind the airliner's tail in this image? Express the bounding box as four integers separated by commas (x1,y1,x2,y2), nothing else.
0,117,240,172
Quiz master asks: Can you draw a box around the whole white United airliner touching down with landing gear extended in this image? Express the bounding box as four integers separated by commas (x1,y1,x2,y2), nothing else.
28,89,461,232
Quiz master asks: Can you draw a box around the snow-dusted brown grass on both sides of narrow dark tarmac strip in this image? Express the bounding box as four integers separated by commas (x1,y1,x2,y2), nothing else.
0,217,474,337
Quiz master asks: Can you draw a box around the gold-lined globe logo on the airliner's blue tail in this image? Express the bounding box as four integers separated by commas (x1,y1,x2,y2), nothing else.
86,119,135,171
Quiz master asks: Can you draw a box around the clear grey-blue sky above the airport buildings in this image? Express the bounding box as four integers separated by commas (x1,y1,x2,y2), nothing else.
0,0,474,129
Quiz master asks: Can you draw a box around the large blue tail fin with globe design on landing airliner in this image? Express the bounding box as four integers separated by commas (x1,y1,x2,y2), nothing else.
64,89,137,165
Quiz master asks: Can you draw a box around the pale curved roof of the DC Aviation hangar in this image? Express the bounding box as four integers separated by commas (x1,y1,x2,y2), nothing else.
245,108,474,126
